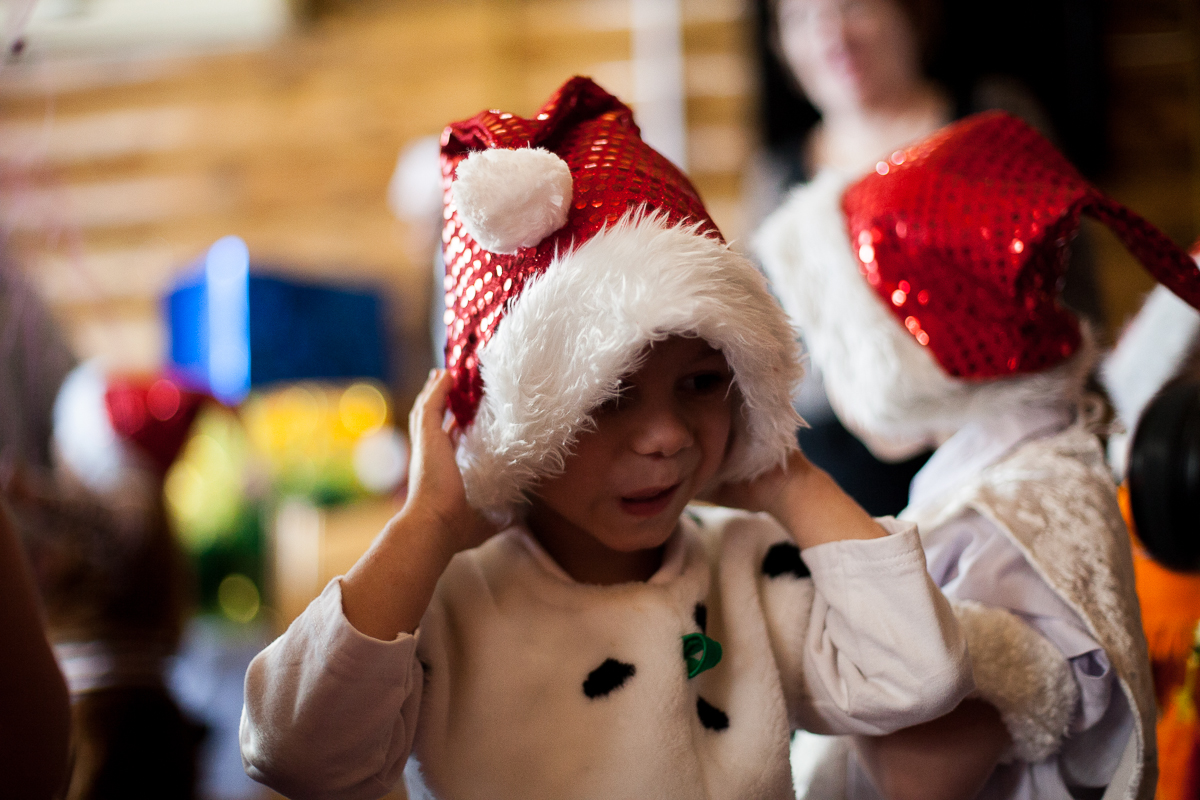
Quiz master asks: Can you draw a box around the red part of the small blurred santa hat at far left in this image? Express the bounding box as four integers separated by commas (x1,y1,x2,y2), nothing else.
104,377,208,475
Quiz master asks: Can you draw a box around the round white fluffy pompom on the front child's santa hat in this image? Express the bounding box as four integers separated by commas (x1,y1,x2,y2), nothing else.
450,148,572,253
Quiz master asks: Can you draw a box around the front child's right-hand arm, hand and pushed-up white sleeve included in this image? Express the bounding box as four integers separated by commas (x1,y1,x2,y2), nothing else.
715,452,973,735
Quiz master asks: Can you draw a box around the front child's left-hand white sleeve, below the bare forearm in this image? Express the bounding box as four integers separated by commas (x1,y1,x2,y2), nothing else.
239,579,422,800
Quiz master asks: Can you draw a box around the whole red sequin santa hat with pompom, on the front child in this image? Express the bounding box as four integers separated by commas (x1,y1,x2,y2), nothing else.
442,78,800,517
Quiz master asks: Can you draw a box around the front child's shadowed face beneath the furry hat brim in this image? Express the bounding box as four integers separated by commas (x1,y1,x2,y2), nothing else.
529,336,737,582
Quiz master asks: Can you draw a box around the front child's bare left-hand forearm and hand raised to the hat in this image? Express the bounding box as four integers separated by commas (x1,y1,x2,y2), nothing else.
342,371,494,642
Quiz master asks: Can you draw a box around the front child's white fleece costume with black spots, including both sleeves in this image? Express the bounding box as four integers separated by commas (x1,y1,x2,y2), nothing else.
241,507,971,800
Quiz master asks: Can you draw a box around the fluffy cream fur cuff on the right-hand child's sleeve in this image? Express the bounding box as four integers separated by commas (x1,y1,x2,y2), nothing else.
950,600,1079,763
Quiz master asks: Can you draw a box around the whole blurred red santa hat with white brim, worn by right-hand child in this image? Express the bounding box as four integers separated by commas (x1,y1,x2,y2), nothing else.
756,112,1200,457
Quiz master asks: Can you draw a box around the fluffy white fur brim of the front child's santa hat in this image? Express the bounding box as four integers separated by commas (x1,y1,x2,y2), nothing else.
458,213,802,518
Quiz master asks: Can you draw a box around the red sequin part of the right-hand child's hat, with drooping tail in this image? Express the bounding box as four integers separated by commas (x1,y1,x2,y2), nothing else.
842,112,1200,379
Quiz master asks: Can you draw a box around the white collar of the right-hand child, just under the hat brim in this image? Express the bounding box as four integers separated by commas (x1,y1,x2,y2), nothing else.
908,405,1075,507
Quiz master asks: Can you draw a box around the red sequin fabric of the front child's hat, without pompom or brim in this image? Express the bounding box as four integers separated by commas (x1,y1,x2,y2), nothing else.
442,77,720,427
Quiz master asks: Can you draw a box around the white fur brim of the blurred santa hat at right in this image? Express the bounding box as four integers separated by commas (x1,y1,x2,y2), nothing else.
754,170,1094,461
